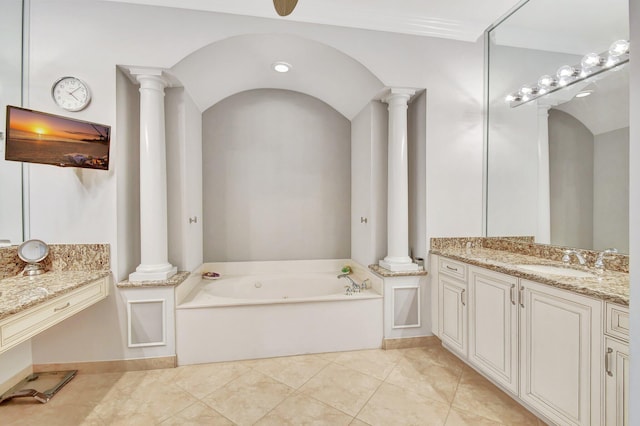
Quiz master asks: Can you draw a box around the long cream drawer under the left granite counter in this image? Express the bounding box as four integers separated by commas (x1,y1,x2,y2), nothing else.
0,278,108,351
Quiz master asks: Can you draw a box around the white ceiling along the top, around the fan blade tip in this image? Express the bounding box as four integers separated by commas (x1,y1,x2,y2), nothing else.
99,0,520,42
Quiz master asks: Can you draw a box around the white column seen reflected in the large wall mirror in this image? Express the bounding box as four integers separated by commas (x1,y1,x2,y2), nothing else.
536,105,551,244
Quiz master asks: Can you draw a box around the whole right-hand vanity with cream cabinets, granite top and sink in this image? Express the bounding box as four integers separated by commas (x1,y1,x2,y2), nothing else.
430,239,629,425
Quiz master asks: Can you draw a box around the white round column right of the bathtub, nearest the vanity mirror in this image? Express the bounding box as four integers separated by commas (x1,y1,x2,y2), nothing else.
379,89,418,271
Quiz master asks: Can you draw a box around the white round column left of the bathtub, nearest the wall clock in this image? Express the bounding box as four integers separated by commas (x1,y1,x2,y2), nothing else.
129,69,177,281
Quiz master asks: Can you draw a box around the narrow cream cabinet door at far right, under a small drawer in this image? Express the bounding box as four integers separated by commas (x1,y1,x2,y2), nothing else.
604,337,629,426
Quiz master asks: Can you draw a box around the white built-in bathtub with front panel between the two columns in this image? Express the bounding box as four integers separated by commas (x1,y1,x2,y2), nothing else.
176,259,383,365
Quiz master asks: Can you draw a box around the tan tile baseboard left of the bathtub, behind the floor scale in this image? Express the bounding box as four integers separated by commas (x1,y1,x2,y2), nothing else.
33,356,178,374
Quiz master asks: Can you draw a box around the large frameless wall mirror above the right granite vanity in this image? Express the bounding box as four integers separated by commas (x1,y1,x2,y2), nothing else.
485,0,629,253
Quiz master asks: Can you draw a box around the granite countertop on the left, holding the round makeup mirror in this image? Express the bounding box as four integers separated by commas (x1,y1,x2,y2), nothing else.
0,270,111,320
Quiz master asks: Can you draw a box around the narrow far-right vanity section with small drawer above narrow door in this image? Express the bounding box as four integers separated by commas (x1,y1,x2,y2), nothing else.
604,302,629,426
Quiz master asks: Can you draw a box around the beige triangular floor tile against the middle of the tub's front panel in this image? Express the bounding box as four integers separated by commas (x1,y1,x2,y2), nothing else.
253,355,330,389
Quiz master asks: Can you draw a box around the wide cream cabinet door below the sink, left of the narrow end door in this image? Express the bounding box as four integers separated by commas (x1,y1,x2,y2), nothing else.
520,280,602,425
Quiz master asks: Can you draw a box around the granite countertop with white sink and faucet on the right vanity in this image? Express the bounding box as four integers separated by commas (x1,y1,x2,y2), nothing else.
431,248,629,306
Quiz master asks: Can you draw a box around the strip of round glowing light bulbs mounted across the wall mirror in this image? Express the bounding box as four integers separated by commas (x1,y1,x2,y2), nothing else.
505,40,629,108
